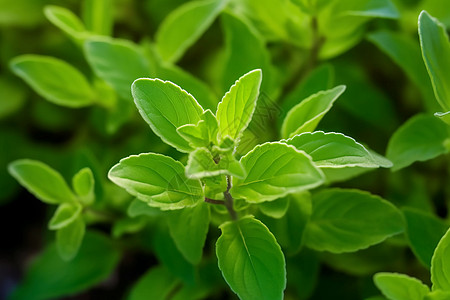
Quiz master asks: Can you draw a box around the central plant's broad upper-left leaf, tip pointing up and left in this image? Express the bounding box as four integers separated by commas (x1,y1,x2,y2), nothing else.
131,79,203,152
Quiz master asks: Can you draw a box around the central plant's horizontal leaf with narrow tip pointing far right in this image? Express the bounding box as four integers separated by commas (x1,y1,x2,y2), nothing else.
285,131,392,168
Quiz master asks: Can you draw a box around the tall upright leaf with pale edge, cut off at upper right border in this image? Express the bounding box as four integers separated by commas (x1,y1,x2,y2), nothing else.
419,11,450,111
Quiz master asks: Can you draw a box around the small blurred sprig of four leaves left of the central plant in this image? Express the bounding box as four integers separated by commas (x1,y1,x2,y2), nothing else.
8,159,95,260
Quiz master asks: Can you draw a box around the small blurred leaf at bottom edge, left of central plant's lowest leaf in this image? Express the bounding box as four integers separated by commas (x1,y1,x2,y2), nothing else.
127,266,180,300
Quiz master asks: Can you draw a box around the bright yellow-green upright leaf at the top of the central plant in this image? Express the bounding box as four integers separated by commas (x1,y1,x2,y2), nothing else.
216,69,262,140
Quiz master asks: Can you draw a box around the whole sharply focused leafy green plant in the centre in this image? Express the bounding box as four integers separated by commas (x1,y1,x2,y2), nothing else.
104,69,403,299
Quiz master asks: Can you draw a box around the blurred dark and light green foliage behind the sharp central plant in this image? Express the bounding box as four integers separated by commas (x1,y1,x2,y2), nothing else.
0,0,450,299
